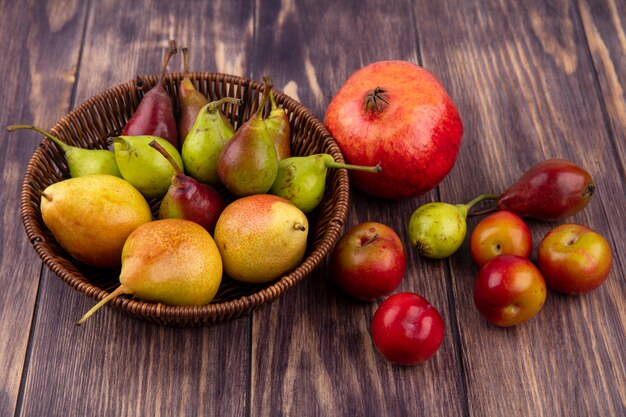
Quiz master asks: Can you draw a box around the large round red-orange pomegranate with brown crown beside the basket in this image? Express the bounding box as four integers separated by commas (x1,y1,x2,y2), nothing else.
324,61,463,199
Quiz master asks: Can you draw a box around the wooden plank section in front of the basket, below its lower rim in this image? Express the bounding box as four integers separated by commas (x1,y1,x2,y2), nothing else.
22,273,250,417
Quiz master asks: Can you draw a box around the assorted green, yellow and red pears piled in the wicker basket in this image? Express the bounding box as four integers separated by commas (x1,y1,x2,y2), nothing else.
8,41,380,323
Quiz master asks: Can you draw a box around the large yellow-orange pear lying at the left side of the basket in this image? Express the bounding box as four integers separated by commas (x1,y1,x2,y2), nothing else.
40,175,152,268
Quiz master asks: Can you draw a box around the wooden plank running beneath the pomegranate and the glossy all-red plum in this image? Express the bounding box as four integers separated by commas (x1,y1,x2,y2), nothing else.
251,1,463,416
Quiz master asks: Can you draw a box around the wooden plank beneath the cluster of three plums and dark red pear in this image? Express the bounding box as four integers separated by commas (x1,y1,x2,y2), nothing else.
415,1,626,416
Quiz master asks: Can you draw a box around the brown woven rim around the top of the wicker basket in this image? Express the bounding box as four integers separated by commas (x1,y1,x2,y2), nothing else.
20,72,349,325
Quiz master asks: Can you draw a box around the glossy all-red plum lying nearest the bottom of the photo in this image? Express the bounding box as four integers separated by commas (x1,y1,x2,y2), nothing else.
372,292,444,365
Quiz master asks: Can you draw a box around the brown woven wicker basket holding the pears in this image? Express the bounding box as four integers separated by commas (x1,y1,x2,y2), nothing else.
21,72,349,326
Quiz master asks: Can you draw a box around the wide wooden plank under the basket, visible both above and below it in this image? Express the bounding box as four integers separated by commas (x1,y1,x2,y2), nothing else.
22,0,252,416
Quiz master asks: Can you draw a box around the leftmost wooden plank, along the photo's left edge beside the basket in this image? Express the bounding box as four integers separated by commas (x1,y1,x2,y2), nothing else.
0,1,85,416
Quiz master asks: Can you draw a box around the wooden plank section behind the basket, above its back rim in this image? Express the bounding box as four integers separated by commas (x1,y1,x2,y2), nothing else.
77,0,253,103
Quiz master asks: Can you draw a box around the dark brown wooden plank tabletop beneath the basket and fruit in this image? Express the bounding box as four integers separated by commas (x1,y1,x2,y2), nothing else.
0,0,626,417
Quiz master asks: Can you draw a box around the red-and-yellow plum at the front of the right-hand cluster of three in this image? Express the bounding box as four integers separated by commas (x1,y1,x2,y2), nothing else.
473,255,546,327
